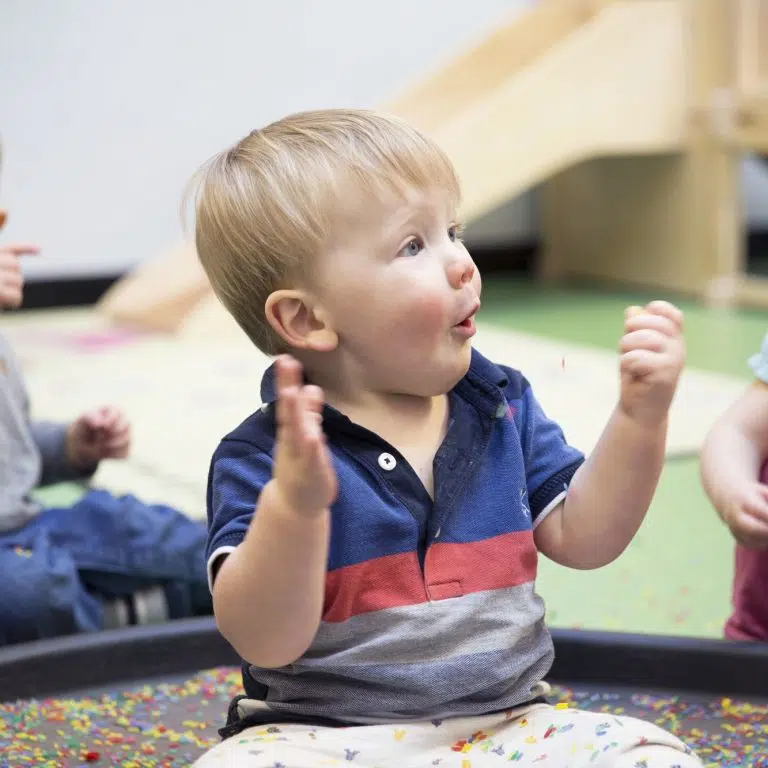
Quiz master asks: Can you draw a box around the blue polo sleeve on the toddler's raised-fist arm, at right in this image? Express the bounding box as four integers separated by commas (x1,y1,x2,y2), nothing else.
520,381,584,526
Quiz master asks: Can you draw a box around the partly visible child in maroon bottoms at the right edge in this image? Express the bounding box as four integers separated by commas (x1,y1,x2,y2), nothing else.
701,335,768,642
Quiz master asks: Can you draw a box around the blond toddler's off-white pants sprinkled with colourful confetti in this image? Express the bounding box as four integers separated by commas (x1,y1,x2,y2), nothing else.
195,704,702,768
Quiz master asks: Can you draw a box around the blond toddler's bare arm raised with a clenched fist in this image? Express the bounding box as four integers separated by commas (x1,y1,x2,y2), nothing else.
535,302,685,568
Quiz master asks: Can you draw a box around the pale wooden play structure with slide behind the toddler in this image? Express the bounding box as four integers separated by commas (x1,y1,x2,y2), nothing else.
100,0,768,329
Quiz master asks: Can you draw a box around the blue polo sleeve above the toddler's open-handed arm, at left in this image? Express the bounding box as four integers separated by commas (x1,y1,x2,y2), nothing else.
205,440,272,589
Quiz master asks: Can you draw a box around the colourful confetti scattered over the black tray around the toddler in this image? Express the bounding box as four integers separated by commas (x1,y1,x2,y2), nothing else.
0,667,768,768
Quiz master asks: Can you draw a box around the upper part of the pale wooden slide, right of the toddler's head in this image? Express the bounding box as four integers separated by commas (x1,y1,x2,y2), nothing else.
386,0,686,226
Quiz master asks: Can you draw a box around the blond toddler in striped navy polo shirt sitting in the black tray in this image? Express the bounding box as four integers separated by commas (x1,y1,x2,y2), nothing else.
189,110,700,768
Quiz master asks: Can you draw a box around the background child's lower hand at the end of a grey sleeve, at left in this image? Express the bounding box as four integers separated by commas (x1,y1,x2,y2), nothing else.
67,406,131,469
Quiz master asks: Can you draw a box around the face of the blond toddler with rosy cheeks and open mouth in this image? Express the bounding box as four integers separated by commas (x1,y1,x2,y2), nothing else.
312,189,480,396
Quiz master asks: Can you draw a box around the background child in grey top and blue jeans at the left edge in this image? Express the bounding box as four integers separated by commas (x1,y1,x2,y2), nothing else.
0,212,211,645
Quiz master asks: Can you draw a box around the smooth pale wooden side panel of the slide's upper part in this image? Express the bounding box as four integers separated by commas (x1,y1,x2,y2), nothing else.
432,0,685,225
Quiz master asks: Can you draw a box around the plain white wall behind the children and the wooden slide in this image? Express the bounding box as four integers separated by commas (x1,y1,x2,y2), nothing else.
0,0,768,278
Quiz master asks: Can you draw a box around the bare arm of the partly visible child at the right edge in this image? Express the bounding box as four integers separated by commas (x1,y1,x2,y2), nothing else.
701,380,768,548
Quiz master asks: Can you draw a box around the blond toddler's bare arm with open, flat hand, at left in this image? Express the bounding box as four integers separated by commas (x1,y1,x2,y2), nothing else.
213,358,336,668
